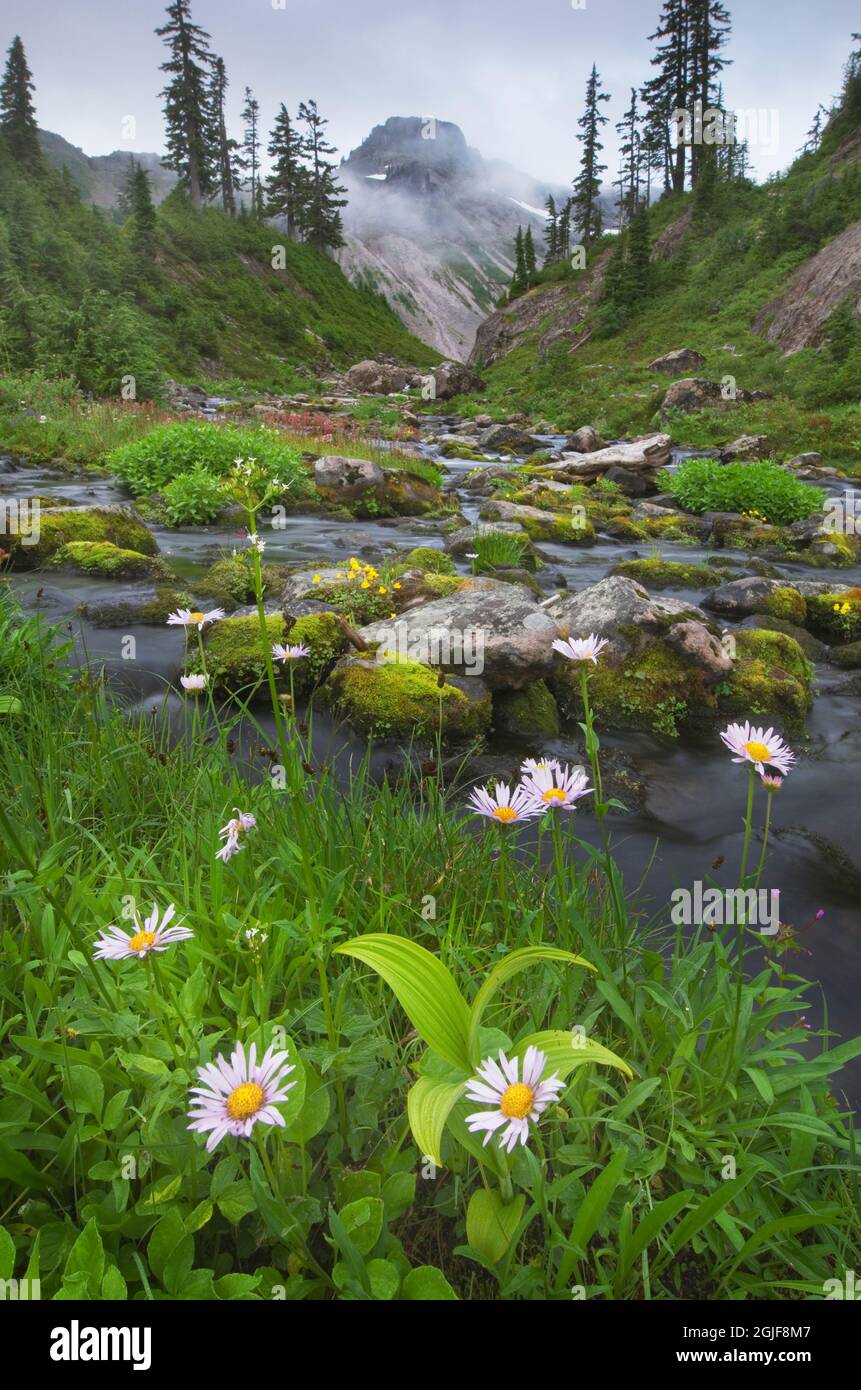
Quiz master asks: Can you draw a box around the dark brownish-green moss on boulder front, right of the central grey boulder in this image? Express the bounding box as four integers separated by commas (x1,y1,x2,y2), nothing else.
551,642,718,737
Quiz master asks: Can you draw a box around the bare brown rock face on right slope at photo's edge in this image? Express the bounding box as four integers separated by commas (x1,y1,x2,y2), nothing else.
753,221,861,352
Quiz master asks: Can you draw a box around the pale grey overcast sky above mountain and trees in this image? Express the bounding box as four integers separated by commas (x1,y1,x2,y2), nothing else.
0,0,861,183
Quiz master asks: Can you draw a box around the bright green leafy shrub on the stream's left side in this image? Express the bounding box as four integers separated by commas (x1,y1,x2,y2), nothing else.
107,420,313,496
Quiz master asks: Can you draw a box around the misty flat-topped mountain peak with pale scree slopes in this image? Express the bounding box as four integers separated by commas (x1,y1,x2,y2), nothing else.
339,117,578,360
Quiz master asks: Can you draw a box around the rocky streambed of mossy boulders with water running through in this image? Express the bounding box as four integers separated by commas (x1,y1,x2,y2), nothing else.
0,416,861,1081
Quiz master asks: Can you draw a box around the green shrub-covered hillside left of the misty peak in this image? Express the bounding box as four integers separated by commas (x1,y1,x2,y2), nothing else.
0,152,435,399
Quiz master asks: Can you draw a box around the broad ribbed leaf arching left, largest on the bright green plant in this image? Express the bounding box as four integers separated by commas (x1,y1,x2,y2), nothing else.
335,933,472,1072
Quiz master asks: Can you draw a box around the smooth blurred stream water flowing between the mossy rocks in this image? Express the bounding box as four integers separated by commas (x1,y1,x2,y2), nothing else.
0,428,861,1098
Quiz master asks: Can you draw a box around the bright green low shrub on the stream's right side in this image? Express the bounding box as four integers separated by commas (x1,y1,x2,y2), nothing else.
666,459,823,525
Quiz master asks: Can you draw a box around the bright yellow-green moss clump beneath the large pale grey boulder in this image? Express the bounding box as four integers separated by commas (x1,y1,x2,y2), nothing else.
327,662,491,739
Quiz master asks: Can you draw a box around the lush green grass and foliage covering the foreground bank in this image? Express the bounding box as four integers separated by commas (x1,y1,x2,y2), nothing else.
0,596,861,1304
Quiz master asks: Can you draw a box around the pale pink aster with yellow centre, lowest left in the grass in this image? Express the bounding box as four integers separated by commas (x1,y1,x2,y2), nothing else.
188,1043,296,1154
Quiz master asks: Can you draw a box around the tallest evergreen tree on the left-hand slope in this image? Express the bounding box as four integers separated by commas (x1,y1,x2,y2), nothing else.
156,0,214,207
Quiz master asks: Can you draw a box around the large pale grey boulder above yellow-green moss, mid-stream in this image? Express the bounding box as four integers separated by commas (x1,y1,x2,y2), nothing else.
360,580,558,689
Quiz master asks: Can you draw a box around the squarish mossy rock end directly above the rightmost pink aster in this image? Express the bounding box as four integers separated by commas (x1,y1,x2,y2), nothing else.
719,628,814,731
